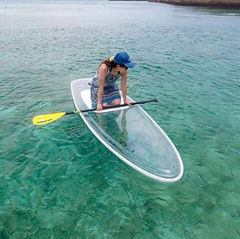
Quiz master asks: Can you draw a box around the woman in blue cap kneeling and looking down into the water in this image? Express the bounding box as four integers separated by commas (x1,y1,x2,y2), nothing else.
91,52,135,111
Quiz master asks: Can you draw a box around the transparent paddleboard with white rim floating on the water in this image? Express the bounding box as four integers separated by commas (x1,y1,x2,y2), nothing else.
71,78,184,182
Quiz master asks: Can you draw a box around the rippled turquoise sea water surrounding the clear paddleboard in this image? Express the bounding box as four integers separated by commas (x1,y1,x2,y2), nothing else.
0,1,240,239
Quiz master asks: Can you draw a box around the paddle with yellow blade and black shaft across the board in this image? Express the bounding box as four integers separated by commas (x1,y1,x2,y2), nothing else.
32,99,158,125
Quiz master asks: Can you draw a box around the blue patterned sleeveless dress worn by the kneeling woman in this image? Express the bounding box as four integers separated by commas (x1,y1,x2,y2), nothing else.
91,68,121,108
